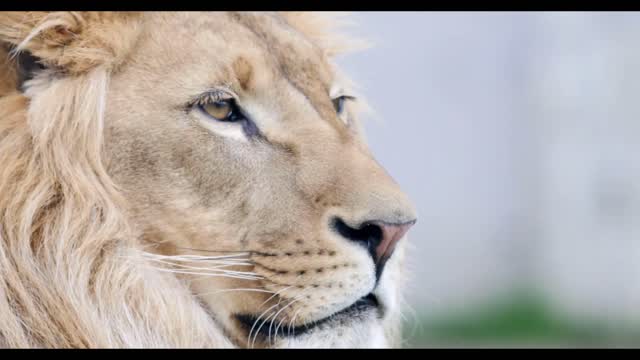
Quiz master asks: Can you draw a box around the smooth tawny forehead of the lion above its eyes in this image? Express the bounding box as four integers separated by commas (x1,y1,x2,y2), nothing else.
133,13,335,124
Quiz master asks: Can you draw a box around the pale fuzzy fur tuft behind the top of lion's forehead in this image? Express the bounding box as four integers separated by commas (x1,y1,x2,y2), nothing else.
280,11,370,57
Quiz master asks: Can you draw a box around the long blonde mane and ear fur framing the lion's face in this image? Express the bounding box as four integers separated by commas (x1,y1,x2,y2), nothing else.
0,13,376,347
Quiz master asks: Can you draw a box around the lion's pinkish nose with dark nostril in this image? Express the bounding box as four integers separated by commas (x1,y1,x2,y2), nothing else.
333,218,416,279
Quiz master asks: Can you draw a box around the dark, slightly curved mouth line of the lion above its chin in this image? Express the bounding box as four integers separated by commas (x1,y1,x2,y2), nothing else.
236,293,382,338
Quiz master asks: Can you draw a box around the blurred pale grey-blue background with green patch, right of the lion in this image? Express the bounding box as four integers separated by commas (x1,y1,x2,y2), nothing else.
339,12,640,347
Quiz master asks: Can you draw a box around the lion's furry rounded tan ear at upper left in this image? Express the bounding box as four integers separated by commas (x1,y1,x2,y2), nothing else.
0,11,140,74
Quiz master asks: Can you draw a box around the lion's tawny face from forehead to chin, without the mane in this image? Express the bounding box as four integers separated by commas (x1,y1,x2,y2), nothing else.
105,13,416,346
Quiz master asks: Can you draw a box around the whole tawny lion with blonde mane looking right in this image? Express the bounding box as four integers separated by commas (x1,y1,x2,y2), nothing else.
0,12,417,348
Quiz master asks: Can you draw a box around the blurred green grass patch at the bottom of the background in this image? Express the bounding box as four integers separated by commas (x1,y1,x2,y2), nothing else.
405,290,640,347
